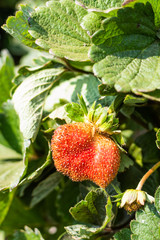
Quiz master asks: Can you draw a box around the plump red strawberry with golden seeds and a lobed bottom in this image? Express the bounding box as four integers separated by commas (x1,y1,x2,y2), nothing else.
51,122,120,188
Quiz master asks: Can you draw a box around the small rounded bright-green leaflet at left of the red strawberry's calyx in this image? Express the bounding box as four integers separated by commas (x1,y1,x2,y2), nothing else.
65,103,84,122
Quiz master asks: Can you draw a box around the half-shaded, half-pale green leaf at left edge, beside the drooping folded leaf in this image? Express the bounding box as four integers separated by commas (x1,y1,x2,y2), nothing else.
0,101,29,190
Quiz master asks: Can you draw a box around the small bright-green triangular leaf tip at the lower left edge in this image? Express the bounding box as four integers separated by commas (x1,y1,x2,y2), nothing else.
0,191,15,225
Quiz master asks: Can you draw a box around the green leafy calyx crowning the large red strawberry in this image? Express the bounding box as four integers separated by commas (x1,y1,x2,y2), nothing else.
65,95,124,148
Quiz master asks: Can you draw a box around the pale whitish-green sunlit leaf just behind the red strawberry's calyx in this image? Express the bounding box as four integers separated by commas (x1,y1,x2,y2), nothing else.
44,73,101,111
